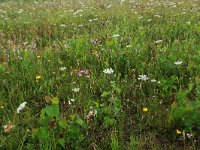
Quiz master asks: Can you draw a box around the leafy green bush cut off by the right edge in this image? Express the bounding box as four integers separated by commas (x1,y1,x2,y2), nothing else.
169,83,200,133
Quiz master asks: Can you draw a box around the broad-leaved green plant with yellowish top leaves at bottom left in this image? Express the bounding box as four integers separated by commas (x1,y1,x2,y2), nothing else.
33,97,87,149
